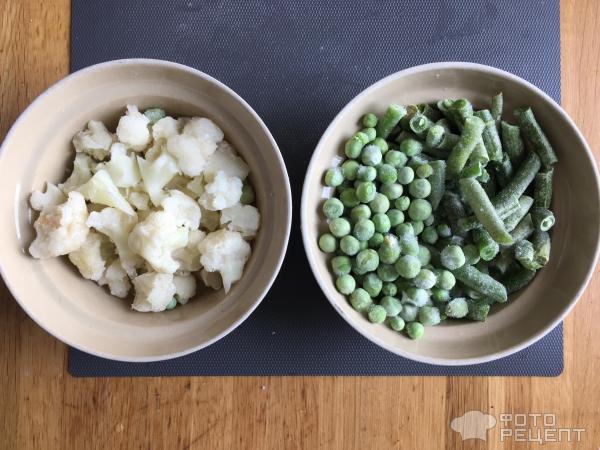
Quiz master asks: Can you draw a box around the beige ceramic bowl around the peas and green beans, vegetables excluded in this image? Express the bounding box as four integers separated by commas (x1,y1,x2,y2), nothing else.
301,62,600,365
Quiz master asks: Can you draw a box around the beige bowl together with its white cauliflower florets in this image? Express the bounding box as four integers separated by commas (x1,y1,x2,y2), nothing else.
0,59,291,361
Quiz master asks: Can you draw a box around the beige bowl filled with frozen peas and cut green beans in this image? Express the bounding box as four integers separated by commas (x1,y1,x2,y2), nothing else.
301,63,600,365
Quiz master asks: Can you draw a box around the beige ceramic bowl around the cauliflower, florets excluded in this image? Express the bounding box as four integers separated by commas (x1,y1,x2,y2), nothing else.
0,59,291,361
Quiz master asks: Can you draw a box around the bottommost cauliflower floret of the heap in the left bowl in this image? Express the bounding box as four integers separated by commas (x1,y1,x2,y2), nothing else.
131,272,177,312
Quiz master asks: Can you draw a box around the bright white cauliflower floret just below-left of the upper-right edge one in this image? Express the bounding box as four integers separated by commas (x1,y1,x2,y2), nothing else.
167,134,217,177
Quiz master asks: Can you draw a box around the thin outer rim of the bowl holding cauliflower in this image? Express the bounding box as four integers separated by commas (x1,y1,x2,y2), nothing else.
0,58,293,363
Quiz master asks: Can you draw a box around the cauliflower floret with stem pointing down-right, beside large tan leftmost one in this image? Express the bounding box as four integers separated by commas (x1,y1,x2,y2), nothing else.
87,208,143,277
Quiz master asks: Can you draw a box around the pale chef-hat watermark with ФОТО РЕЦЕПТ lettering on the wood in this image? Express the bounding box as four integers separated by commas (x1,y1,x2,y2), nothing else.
450,411,584,442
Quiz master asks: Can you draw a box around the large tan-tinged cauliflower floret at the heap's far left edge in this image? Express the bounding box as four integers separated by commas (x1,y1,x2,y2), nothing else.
29,192,90,259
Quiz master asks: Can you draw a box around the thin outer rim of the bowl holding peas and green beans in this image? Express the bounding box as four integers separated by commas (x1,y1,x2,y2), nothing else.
300,61,600,366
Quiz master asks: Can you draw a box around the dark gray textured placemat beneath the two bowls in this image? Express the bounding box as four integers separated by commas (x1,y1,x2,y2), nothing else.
69,0,563,376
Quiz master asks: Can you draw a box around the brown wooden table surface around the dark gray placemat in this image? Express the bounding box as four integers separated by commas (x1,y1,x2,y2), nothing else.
0,0,600,450
